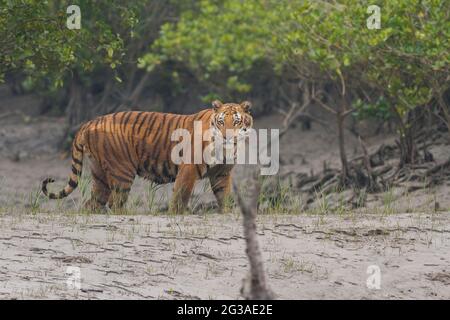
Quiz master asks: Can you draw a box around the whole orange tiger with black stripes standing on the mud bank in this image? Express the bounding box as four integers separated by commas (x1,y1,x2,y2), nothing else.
42,100,253,213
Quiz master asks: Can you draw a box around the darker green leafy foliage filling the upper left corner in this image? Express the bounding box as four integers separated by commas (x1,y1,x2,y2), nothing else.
0,0,155,89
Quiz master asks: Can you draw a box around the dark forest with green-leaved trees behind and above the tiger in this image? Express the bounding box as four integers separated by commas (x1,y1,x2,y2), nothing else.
0,0,450,183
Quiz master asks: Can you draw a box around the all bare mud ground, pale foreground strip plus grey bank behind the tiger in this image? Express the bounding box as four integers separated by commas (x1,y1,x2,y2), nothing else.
0,120,450,299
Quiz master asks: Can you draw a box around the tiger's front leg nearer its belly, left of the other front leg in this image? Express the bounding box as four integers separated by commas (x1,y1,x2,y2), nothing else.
169,164,202,213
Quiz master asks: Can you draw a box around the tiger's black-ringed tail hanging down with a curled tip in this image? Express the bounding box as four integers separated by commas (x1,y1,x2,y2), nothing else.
41,130,84,199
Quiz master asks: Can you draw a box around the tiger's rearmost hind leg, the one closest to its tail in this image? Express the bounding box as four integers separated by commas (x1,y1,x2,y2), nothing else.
85,159,111,212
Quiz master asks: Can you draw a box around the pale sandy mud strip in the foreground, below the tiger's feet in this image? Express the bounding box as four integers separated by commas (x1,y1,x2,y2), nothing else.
0,212,450,299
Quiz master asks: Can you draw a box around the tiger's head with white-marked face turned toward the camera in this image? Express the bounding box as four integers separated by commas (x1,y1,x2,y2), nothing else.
211,100,253,145
